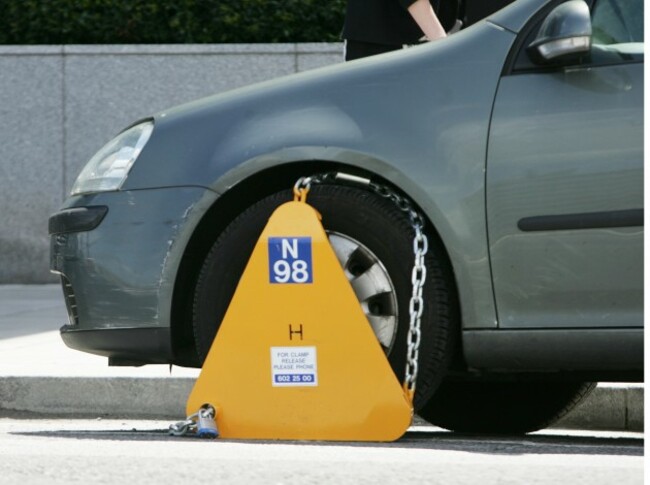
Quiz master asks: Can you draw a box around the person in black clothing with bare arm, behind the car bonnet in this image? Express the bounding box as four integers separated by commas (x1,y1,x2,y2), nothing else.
343,0,447,61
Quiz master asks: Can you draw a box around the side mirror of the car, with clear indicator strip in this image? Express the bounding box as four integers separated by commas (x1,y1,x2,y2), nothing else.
528,0,591,64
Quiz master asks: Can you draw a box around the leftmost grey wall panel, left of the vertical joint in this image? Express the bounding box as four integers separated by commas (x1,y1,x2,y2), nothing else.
0,51,63,283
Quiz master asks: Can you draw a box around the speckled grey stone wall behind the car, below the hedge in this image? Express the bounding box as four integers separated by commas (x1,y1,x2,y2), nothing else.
0,44,343,284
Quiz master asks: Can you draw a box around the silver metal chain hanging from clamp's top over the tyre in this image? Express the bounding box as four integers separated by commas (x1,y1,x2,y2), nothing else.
293,173,429,401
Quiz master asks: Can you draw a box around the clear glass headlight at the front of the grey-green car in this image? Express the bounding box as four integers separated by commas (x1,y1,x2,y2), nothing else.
72,121,153,195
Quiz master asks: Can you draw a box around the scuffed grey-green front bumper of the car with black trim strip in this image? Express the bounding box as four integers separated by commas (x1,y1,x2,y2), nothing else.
50,187,216,363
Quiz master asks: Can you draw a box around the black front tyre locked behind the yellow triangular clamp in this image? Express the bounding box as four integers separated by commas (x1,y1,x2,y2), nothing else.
193,185,458,408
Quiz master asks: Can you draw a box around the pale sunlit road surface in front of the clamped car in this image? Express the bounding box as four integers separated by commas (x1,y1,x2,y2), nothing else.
0,418,644,485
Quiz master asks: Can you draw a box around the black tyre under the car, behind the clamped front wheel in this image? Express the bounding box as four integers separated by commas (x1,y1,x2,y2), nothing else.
418,381,596,434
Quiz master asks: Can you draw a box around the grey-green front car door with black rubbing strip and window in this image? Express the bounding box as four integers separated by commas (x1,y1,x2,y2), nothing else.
486,0,644,329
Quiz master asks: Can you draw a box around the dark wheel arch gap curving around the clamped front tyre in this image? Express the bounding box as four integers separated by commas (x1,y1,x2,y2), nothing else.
170,157,462,367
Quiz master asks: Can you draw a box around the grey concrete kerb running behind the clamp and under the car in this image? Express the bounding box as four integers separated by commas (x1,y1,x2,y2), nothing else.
0,377,644,432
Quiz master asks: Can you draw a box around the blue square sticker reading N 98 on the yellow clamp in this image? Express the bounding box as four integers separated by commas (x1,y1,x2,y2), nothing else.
269,237,313,284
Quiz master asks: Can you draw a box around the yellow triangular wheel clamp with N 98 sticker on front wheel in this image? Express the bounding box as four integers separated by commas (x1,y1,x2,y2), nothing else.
175,176,413,441
